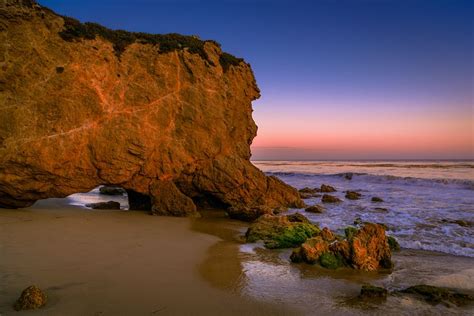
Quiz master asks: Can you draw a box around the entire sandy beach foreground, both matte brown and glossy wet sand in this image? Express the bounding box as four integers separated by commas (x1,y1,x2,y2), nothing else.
0,199,474,315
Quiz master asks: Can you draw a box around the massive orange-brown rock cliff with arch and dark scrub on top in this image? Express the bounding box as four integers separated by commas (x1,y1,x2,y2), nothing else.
0,0,303,215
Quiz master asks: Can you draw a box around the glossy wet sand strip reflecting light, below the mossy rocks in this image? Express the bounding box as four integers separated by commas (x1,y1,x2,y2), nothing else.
192,212,474,315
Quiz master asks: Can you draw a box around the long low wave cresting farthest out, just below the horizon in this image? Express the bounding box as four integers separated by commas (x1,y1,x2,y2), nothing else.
266,171,474,190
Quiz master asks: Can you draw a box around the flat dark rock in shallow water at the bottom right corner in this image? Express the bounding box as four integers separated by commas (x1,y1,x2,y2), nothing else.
400,284,474,306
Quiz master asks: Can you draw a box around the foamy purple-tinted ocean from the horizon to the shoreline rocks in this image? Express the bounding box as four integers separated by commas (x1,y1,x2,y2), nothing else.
253,161,474,257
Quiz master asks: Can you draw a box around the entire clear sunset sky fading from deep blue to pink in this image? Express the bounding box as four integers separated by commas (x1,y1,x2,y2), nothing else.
39,0,474,160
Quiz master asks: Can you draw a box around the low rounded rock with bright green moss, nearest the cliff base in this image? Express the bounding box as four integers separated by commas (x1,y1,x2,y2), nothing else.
245,214,319,249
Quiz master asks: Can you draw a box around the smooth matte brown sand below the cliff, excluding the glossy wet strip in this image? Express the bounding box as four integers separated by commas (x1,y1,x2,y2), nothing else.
0,199,295,315
